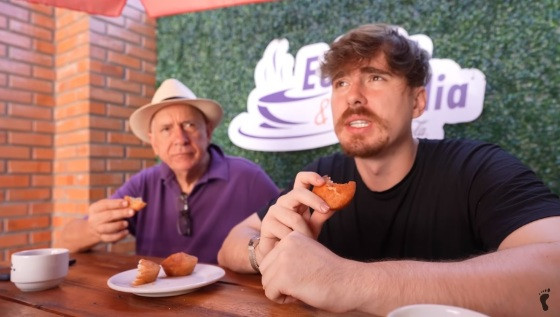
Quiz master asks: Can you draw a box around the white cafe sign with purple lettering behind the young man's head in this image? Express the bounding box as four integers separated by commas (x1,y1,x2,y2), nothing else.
228,29,486,151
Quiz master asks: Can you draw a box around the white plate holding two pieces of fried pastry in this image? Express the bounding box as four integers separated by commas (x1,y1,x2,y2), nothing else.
107,264,226,297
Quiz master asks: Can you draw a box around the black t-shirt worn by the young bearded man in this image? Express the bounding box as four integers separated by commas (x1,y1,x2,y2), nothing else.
259,140,560,261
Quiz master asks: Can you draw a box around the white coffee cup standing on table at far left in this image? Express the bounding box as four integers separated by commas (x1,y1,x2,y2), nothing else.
10,248,69,292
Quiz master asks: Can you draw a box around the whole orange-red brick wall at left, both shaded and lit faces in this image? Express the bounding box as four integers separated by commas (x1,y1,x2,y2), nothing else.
0,0,157,261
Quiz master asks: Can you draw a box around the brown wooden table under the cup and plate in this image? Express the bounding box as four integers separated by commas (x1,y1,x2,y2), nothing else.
0,252,363,317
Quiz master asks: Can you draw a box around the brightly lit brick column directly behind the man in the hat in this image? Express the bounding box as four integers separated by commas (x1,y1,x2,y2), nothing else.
53,1,157,251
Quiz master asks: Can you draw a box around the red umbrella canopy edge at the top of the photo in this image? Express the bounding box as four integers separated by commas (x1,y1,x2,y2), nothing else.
21,0,275,18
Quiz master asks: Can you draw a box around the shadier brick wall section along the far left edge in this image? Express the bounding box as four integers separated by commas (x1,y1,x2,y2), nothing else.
0,0,55,261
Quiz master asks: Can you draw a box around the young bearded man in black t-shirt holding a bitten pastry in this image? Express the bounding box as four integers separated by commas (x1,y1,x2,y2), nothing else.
218,24,560,316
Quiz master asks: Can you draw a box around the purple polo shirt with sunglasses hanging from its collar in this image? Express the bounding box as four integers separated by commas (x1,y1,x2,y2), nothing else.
112,145,279,263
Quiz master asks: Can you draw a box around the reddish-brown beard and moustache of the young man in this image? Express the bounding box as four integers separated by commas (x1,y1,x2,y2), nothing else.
335,107,389,158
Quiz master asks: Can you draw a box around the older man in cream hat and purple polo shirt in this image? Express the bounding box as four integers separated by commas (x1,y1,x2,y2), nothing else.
58,79,278,263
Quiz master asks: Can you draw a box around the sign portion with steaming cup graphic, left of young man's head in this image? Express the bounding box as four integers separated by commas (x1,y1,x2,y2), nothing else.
228,39,338,151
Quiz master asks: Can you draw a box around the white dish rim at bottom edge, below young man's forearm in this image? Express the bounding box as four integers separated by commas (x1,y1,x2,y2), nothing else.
387,304,488,317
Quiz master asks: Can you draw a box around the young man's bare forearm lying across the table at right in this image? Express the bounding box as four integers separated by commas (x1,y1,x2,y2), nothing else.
354,242,560,316
